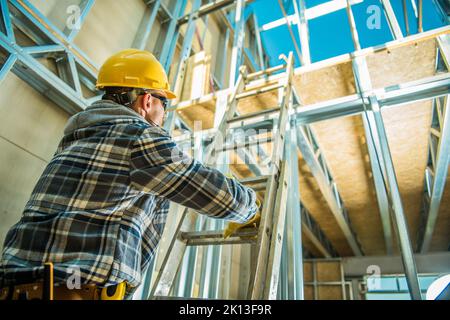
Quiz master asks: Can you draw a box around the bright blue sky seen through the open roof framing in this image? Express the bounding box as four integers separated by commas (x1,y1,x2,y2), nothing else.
246,0,444,66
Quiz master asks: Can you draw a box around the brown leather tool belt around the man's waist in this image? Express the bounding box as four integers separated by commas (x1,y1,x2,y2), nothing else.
0,263,126,300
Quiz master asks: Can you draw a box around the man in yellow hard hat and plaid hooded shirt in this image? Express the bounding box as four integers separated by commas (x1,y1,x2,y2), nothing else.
0,49,258,300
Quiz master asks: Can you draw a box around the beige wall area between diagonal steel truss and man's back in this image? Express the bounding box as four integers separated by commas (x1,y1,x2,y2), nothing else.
0,73,69,252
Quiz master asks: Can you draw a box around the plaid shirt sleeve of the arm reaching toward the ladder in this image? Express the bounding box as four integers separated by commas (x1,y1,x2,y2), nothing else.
130,127,258,223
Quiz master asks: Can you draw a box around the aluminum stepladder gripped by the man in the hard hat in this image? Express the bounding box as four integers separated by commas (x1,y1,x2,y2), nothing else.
149,52,294,299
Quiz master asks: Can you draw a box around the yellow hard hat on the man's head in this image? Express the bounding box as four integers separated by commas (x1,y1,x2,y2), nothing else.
97,49,176,99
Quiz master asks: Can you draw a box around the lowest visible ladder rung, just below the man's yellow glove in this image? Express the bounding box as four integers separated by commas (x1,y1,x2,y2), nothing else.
181,229,258,246
